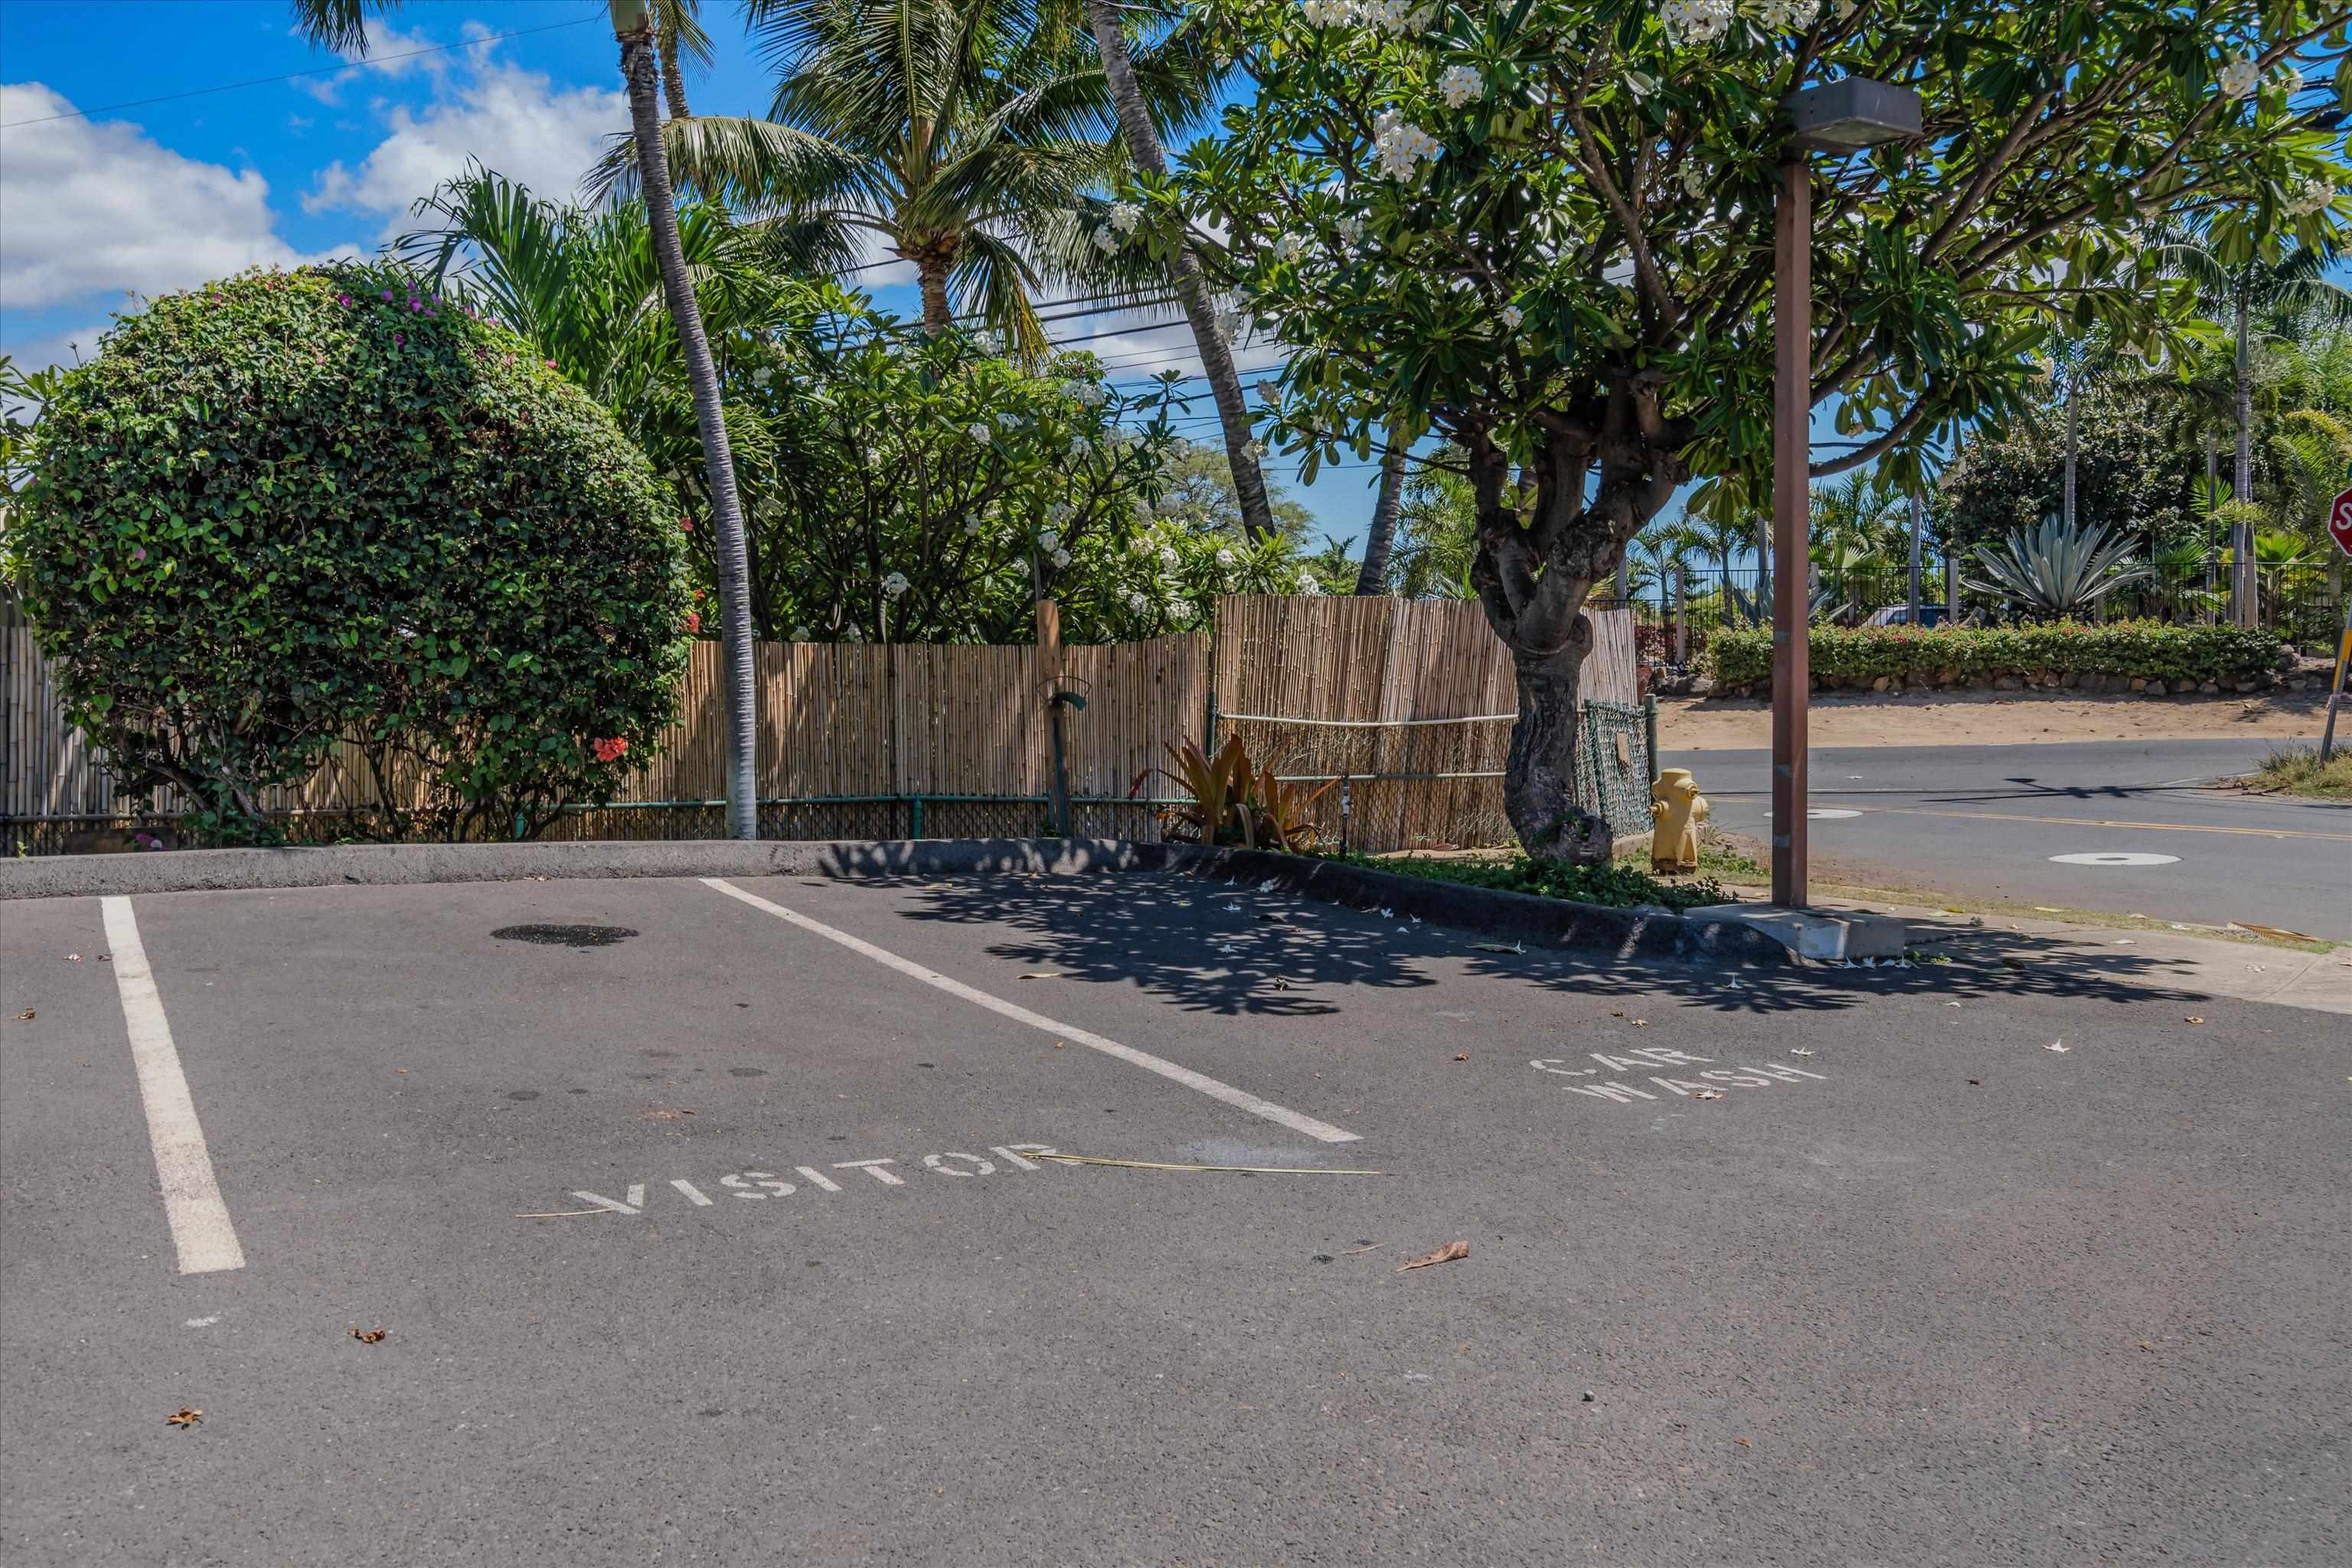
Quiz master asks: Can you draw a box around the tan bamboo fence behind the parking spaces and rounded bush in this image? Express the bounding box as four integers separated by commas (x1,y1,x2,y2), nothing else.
0,595,1632,854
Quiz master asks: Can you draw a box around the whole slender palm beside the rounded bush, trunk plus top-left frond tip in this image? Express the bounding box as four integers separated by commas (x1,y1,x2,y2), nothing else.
289,0,760,839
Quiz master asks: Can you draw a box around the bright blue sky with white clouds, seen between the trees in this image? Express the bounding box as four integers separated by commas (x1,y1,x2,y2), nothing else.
0,0,1376,536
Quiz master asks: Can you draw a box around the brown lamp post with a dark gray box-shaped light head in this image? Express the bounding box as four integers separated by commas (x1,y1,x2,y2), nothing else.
1771,75,1919,910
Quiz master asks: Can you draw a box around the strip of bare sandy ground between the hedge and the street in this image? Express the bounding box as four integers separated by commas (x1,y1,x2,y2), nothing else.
1658,691,2345,750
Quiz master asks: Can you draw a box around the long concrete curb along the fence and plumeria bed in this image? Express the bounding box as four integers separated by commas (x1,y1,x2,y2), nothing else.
0,839,1799,966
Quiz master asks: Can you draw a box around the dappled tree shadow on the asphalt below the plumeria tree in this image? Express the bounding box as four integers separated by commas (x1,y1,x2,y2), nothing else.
879,872,2209,1018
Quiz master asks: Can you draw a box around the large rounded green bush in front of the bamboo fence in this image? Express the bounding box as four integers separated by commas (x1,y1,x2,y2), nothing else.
0,266,691,839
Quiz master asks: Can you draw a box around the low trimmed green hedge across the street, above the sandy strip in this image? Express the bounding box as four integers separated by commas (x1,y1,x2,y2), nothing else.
1705,621,2284,687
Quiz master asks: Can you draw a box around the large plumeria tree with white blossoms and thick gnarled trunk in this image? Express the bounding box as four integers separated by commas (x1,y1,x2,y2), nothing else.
1166,0,2352,854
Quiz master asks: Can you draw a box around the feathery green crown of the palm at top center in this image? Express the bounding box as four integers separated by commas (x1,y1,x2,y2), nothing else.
635,0,1216,355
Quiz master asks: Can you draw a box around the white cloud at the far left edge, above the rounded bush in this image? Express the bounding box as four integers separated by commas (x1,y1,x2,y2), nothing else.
0,82,348,310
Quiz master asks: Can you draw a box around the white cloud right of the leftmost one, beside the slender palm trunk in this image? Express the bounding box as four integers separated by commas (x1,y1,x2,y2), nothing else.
301,66,628,235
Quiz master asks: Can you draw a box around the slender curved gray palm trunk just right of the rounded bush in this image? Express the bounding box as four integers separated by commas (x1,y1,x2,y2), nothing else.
621,26,760,839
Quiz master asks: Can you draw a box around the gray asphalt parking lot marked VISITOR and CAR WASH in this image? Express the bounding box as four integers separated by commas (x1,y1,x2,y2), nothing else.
0,877,2352,1568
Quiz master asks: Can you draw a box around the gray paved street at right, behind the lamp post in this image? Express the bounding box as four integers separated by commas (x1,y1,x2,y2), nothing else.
1665,740,2352,940
